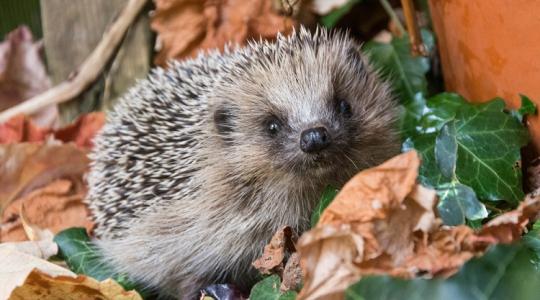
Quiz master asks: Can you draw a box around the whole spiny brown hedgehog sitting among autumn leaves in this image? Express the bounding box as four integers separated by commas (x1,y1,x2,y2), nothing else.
86,28,400,299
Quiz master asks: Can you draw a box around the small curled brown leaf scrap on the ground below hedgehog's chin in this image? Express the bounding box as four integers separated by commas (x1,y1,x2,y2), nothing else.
253,226,298,274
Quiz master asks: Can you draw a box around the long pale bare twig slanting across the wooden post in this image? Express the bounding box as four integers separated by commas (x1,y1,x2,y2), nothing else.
0,0,147,123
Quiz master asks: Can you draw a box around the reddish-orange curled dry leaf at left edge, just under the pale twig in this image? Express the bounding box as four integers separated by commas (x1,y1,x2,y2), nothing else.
0,112,105,149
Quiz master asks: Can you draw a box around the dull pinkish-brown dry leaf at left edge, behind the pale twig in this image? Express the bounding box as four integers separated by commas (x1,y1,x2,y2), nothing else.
0,26,58,126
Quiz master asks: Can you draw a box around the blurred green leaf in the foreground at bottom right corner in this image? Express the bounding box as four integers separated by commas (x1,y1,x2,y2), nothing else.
345,245,540,300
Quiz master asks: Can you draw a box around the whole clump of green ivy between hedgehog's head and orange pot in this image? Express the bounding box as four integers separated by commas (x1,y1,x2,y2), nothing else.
364,26,535,225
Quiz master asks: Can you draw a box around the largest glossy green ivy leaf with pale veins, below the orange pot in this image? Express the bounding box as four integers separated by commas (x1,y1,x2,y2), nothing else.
403,94,528,199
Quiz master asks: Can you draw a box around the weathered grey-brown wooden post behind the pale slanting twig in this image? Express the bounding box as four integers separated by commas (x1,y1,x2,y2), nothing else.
41,0,153,123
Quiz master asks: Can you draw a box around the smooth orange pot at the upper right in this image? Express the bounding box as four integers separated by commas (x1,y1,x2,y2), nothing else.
429,0,540,150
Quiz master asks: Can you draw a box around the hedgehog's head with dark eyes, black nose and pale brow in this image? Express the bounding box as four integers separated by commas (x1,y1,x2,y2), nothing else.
207,29,399,186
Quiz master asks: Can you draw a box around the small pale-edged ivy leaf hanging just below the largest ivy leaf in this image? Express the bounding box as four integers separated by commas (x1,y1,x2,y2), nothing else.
437,182,488,225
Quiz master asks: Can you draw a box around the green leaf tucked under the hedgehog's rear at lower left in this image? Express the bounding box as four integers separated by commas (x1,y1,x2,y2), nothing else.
54,228,143,295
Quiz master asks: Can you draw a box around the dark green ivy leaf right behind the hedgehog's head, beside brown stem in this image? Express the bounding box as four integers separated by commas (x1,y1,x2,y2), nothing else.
364,29,435,104
